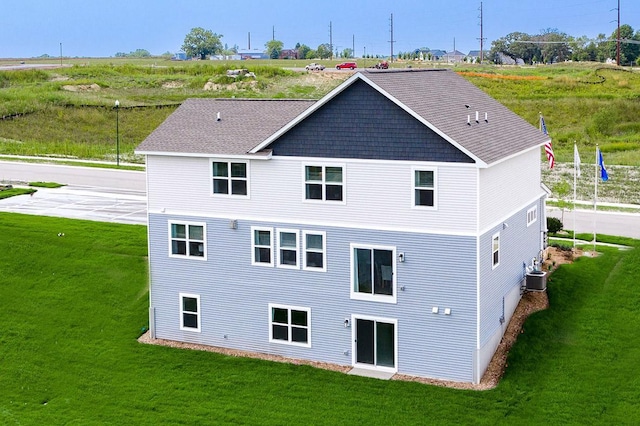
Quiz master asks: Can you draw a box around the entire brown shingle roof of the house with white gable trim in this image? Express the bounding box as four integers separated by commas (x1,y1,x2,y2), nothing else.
136,69,549,167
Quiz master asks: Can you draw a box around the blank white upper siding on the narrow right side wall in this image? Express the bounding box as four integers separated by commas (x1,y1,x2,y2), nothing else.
479,148,543,233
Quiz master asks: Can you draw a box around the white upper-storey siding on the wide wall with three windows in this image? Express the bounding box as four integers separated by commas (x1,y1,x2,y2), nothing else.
147,156,477,235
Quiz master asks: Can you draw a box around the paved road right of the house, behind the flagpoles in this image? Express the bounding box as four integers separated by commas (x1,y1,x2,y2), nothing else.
547,208,640,239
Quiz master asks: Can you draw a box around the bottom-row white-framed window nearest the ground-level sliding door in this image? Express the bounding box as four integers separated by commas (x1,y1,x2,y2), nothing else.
269,303,311,348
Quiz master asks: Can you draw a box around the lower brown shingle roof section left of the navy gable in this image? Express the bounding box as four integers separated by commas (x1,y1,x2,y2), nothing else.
136,99,315,155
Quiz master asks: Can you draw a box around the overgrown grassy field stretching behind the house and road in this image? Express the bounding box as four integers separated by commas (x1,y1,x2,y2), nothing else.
0,58,640,204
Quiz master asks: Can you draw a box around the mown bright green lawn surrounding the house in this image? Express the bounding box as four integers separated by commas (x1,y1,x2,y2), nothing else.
0,213,640,425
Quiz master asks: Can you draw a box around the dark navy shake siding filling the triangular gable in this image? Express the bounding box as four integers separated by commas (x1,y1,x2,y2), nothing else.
269,81,473,163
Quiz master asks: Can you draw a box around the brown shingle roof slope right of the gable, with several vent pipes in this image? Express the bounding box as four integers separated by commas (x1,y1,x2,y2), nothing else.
362,70,549,164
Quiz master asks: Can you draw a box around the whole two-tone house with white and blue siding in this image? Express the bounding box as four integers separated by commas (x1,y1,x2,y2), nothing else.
137,69,547,383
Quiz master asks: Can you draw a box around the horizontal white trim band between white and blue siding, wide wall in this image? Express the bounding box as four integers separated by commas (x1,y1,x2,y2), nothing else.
148,209,480,237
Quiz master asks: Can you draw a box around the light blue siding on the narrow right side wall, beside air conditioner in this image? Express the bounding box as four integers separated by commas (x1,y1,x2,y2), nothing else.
478,197,546,379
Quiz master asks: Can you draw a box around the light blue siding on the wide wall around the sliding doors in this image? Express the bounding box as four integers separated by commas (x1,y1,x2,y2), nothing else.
149,214,477,381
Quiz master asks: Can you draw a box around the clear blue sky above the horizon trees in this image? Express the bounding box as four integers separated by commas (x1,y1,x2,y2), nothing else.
0,0,640,58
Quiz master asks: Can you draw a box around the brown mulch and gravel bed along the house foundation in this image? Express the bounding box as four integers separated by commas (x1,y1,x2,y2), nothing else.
138,247,585,390
